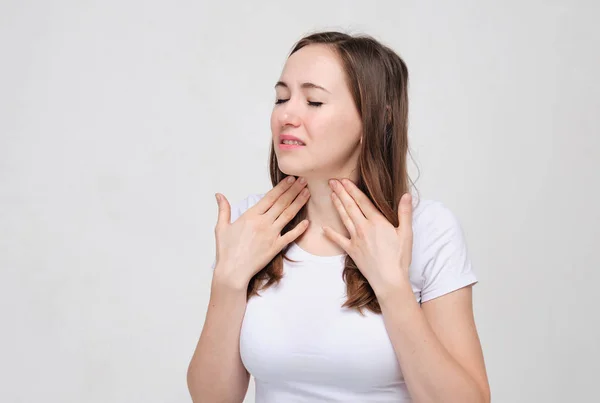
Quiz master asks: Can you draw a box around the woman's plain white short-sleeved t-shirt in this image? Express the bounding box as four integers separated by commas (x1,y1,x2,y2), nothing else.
213,193,477,403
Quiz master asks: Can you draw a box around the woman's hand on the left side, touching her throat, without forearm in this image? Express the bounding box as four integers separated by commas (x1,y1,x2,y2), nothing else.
214,176,310,290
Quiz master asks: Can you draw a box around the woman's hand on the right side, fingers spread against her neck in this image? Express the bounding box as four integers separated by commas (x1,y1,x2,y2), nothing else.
322,179,413,296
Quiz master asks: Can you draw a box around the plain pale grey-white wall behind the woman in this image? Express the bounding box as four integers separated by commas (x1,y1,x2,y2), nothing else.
0,0,600,403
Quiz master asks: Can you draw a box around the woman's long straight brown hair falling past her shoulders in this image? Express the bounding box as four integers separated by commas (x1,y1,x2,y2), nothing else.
247,32,420,314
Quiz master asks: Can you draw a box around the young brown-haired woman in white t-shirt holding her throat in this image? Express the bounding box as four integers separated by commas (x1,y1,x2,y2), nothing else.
187,32,490,403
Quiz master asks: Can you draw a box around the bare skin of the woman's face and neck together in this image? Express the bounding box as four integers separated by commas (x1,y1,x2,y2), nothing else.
271,45,362,256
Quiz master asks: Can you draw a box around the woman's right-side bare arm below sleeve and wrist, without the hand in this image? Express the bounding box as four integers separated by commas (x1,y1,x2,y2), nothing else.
380,287,490,403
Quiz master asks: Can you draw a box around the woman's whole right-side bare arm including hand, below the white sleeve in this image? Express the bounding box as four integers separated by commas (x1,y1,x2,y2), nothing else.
325,179,490,403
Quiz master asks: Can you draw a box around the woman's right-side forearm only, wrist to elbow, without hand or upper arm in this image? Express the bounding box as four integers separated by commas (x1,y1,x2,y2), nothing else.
378,284,485,403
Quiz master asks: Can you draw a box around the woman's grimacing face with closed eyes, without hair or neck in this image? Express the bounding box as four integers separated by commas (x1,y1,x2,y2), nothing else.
271,45,362,179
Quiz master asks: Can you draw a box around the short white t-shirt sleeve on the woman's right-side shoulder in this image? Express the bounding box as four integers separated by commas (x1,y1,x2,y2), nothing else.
421,202,478,303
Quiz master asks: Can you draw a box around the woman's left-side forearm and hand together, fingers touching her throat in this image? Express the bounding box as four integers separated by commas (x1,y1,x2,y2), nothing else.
187,176,310,403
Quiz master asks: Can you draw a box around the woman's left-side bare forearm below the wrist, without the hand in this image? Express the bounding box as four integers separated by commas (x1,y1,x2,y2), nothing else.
187,279,249,402
